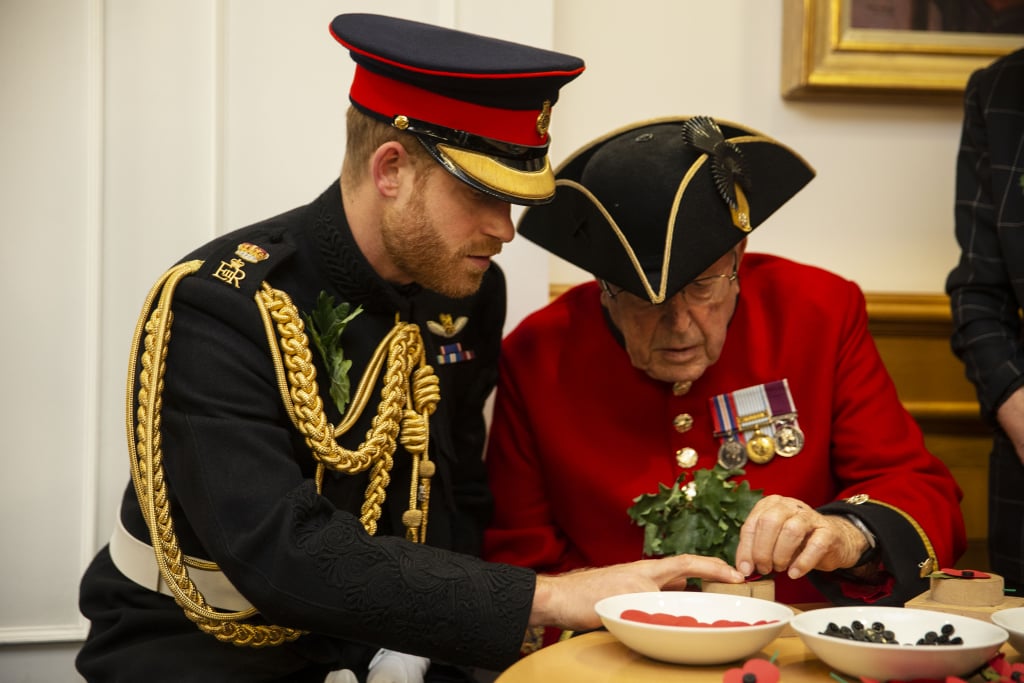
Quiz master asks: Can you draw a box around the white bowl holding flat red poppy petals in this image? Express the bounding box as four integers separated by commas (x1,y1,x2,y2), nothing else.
594,591,793,665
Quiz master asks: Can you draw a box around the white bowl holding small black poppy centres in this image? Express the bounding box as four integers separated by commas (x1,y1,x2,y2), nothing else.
790,606,1007,681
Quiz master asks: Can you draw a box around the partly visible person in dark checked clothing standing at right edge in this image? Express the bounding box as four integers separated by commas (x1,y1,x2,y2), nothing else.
946,49,1024,591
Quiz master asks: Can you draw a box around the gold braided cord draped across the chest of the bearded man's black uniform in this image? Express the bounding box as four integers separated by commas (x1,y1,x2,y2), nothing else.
256,283,440,543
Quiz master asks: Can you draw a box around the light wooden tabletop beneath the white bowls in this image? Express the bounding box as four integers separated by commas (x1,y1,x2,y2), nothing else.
496,631,1021,683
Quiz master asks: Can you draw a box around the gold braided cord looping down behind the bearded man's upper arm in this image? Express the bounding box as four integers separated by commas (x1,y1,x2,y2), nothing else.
126,261,304,647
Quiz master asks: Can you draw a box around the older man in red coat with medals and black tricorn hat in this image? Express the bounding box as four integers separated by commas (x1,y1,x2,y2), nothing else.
484,117,965,643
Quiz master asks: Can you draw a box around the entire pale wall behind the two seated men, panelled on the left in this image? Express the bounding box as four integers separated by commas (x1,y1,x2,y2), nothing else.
0,0,999,683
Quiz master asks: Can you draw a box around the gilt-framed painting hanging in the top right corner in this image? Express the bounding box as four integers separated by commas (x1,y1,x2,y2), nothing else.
781,0,1024,100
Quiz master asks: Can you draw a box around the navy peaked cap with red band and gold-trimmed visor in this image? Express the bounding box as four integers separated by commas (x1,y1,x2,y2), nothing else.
331,13,585,205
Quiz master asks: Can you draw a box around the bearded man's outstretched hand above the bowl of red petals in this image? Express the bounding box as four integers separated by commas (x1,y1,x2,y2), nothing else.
529,555,743,631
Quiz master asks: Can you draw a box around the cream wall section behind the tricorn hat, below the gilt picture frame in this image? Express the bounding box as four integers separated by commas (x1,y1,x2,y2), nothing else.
551,0,961,293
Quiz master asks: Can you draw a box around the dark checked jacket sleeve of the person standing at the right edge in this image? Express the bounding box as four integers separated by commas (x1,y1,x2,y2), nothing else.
946,49,1024,424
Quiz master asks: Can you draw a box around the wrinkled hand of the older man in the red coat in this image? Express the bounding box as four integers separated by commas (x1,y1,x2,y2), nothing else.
736,496,868,579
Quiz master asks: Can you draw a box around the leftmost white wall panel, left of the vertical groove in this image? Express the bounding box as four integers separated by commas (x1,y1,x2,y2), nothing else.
0,0,102,655
